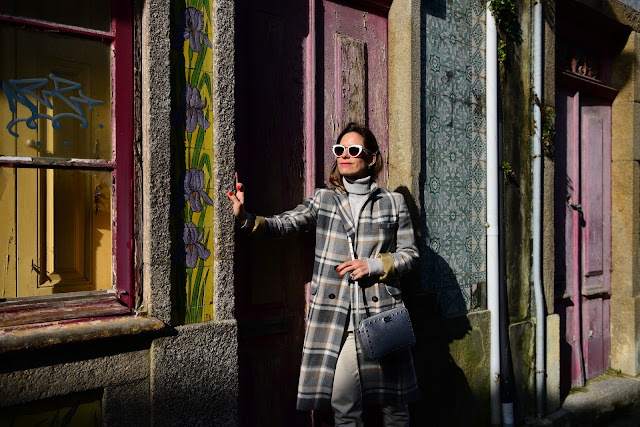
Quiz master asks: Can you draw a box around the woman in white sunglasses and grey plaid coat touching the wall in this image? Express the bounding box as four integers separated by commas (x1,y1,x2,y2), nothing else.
229,123,418,426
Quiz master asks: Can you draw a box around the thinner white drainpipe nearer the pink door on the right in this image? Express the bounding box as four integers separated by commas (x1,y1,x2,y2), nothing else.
531,1,546,416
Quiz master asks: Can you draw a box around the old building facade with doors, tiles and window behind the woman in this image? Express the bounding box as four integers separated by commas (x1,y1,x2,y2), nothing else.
0,0,640,426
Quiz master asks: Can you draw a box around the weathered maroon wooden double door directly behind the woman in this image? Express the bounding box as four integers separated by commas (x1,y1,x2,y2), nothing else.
235,0,390,426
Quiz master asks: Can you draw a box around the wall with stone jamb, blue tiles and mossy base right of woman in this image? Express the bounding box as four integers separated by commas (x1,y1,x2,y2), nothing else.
402,0,490,426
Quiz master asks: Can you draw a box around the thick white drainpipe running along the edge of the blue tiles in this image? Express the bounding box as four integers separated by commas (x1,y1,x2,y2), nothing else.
486,2,500,425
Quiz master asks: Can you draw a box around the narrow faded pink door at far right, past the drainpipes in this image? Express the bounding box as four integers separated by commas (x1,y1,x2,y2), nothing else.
555,88,611,386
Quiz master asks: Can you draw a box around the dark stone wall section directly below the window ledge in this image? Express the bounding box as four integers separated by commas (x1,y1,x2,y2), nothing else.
0,337,150,425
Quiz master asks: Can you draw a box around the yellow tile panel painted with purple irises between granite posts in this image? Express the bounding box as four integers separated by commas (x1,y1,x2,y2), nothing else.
171,0,215,324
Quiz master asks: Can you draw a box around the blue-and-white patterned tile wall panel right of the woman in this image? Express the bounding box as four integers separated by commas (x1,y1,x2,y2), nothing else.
421,0,487,317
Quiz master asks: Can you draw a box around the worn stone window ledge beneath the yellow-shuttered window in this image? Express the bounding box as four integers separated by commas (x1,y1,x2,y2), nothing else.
0,315,166,354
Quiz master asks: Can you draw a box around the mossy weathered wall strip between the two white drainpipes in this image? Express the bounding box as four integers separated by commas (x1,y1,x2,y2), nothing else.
500,0,544,422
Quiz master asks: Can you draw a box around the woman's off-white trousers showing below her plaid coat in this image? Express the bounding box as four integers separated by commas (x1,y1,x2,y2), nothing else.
331,332,409,427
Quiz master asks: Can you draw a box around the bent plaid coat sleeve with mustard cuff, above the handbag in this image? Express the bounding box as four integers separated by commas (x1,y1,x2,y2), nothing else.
377,194,420,281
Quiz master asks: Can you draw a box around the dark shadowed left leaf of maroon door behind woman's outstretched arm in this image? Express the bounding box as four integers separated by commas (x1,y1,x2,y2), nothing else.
235,0,313,427
